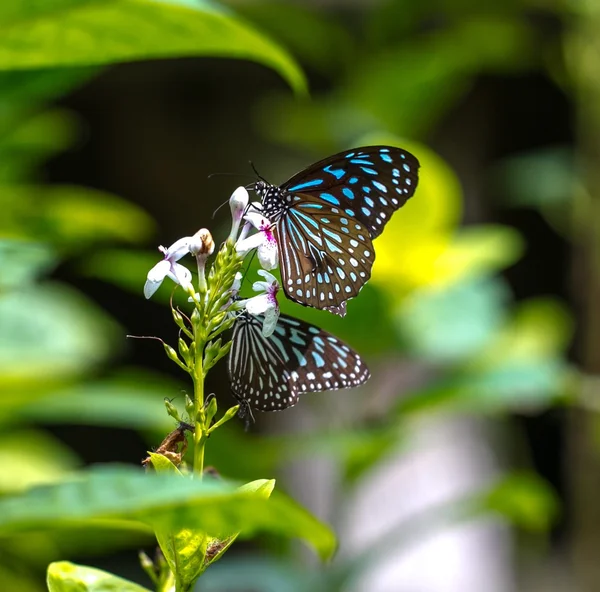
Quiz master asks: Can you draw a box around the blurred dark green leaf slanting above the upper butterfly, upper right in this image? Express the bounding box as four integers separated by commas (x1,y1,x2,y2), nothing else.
345,14,532,136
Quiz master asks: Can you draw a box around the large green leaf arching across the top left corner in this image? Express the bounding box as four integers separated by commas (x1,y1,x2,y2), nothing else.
0,0,305,91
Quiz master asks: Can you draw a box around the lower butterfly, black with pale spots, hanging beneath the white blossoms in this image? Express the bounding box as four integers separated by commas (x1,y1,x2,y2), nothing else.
228,311,370,411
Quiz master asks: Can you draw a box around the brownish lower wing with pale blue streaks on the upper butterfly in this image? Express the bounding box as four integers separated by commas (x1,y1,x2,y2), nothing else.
275,196,375,312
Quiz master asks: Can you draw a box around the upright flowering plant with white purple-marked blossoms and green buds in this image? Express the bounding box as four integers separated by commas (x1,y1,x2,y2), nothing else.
135,187,296,592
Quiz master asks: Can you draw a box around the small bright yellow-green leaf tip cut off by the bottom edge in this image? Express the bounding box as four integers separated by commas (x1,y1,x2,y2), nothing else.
47,561,150,592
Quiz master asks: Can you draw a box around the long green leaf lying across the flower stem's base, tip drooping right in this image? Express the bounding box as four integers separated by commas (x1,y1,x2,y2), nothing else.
0,467,336,559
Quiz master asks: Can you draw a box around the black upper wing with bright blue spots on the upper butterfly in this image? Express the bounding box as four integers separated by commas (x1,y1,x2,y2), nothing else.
281,146,419,238
